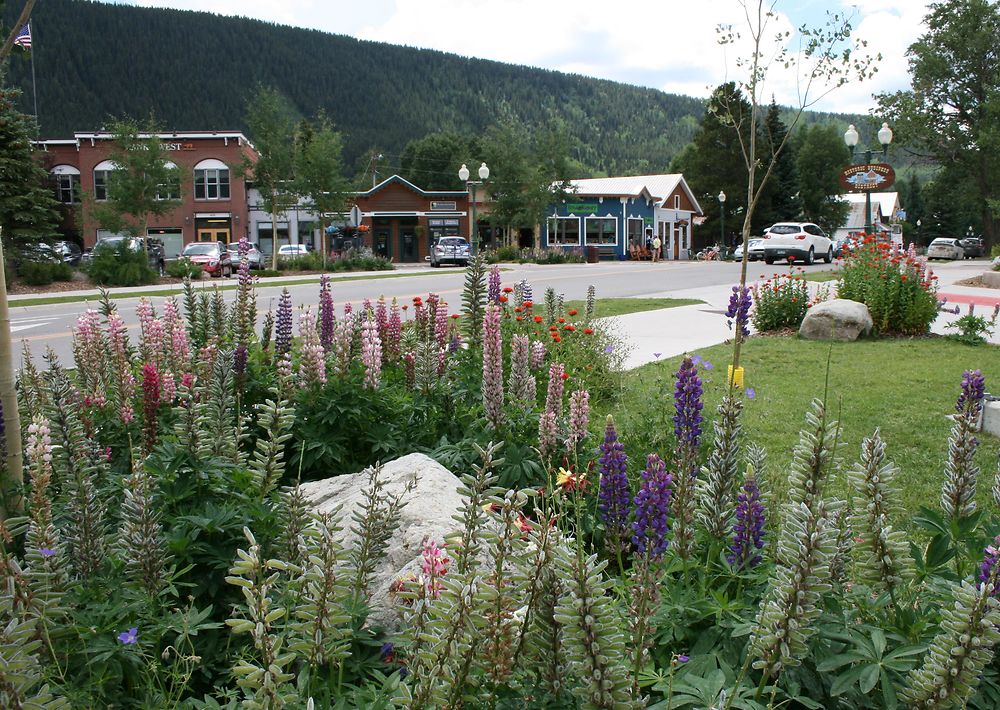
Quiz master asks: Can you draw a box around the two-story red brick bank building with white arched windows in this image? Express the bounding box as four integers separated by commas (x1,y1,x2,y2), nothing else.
36,131,256,258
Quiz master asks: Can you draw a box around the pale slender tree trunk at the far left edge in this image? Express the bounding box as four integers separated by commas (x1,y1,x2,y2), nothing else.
0,236,24,521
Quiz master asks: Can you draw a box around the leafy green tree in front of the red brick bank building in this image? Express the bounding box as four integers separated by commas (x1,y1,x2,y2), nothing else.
88,118,183,236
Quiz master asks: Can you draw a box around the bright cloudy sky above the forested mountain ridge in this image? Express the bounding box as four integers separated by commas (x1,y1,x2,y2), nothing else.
119,0,928,113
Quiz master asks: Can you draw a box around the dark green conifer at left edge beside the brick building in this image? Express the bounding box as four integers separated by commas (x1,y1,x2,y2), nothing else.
0,87,59,260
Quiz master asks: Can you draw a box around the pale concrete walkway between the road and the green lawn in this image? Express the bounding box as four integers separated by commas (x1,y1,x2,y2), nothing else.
616,262,1000,369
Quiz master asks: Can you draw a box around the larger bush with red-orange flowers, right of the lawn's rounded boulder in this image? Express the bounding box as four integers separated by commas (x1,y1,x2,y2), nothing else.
837,237,938,335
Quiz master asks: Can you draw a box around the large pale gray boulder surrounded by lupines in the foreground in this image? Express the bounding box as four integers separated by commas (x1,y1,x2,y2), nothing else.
302,454,465,631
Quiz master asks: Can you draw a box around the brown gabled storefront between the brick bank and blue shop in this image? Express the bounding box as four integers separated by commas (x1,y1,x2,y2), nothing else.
355,175,469,263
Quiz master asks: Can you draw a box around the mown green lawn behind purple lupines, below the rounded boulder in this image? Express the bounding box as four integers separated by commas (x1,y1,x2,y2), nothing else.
594,337,1000,526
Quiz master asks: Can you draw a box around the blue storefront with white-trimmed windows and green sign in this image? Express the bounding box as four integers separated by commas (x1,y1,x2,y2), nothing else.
542,181,656,259
